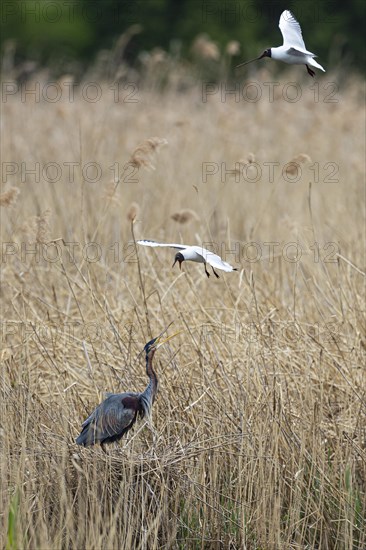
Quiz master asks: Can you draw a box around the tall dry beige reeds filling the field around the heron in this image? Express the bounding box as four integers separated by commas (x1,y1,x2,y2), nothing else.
0,69,366,549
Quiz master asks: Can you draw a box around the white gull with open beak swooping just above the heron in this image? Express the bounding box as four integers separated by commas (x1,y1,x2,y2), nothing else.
137,240,237,279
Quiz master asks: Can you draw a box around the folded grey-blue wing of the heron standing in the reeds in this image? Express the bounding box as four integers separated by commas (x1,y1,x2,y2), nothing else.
76,393,140,445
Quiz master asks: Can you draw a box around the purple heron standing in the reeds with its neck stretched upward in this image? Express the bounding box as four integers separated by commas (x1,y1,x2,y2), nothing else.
76,325,180,452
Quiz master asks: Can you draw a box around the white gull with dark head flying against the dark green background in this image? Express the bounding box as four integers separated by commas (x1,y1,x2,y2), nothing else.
237,10,325,76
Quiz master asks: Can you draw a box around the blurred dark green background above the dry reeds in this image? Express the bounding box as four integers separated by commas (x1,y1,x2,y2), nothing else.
1,0,366,74
